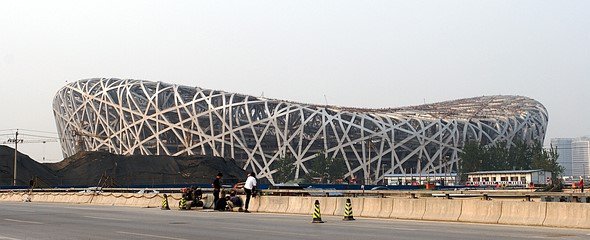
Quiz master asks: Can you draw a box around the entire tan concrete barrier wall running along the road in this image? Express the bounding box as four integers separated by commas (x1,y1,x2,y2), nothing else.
0,192,590,229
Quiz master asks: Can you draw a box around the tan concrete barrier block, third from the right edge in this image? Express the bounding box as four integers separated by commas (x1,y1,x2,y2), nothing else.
459,200,502,223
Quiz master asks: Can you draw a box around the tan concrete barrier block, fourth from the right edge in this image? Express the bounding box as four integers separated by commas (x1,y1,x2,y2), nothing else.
422,198,463,221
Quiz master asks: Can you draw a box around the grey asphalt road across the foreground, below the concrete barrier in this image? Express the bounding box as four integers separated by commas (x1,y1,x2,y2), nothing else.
0,202,590,240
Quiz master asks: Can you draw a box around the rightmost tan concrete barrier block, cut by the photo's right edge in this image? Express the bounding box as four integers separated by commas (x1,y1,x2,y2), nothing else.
543,202,590,228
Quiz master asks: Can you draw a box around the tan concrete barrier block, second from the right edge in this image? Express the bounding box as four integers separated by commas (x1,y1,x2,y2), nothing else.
498,201,547,226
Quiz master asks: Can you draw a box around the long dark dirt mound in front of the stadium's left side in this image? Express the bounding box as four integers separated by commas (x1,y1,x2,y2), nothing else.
47,152,246,187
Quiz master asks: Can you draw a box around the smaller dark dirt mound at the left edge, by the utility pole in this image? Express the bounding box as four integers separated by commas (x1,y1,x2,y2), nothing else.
0,145,58,186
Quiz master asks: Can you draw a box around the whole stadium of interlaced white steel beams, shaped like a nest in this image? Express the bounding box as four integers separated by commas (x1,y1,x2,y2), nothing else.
53,78,547,183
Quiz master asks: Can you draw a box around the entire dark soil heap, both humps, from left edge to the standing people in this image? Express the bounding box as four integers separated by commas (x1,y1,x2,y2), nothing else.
0,146,246,187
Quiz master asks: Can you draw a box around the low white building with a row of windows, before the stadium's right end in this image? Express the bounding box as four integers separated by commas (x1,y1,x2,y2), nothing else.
466,169,551,187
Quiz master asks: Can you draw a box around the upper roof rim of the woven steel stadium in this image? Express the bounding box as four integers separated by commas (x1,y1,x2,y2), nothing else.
59,78,548,120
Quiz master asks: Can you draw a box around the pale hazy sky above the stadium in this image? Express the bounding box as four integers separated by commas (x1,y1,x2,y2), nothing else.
0,0,590,162
